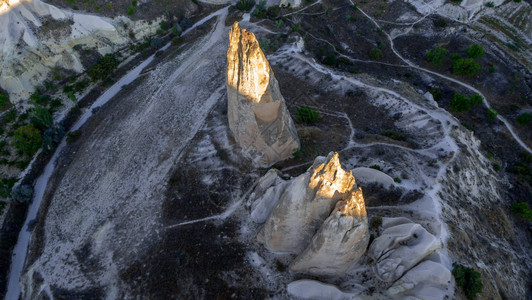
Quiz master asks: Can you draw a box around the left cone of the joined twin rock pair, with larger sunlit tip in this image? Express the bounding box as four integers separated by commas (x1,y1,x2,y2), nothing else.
259,152,360,253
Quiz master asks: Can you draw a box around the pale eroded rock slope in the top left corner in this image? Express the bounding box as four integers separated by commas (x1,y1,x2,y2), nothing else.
0,0,160,103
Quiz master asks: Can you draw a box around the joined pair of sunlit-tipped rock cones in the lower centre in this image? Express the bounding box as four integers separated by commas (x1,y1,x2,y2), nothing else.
259,152,369,266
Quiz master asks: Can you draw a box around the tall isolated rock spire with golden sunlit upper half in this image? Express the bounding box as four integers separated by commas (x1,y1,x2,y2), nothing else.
227,22,300,167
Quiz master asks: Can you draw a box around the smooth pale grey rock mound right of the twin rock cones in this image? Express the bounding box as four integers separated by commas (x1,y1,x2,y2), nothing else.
367,218,442,282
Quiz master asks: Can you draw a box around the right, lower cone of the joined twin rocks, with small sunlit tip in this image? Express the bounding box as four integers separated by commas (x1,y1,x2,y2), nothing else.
290,188,369,276
